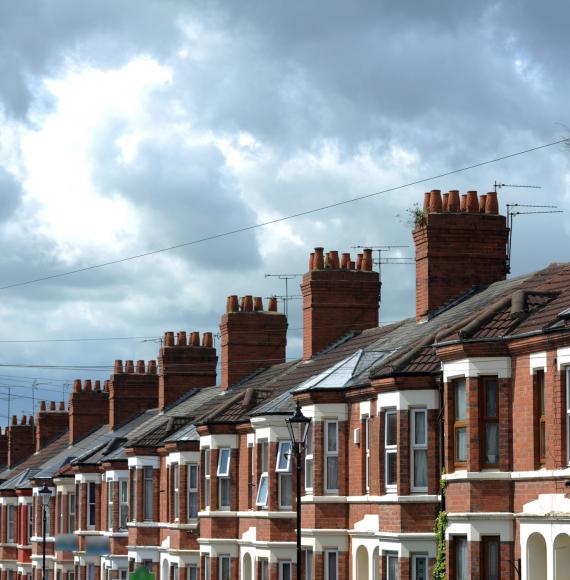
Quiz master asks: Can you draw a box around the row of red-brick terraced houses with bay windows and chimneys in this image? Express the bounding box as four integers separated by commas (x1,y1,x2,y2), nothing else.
0,190,570,580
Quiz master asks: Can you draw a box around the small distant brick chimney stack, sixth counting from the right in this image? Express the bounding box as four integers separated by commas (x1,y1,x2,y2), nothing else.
69,379,109,445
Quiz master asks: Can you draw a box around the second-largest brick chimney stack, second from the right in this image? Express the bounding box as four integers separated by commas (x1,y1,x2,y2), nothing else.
301,248,380,360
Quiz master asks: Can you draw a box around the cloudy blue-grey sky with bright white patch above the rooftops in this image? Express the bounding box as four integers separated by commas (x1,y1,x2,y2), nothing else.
0,0,570,424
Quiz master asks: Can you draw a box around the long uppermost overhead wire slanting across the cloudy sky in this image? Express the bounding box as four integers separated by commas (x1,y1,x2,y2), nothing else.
0,139,560,290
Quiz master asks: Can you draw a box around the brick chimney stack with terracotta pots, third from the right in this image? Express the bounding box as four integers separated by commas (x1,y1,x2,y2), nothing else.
220,296,287,391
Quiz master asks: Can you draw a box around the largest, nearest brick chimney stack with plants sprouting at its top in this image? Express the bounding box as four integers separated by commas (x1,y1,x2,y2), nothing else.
413,189,509,322
